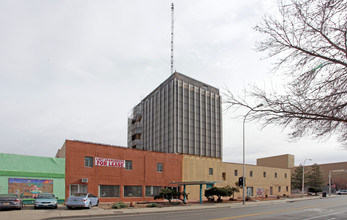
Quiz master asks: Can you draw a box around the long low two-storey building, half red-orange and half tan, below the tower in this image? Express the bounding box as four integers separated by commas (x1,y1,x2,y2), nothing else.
57,140,291,202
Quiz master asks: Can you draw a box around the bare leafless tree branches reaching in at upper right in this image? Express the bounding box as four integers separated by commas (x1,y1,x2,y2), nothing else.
226,0,347,143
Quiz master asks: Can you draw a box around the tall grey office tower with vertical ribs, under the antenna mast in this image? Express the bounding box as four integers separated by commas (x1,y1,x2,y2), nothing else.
128,72,222,158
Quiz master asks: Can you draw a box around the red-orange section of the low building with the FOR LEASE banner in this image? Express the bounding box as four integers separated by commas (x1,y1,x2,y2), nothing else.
56,140,183,202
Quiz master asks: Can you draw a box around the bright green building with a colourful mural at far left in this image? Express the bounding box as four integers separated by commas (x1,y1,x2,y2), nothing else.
0,153,65,204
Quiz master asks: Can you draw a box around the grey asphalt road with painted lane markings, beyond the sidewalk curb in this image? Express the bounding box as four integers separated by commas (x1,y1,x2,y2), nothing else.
59,196,347,220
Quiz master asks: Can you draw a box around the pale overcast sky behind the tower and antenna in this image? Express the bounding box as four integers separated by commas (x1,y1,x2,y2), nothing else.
0,0,347,165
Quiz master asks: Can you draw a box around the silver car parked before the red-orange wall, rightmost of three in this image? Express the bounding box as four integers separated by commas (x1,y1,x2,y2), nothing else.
66,193,99,209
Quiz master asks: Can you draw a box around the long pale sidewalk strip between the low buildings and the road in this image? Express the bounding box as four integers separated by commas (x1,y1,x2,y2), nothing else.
0,196,329,220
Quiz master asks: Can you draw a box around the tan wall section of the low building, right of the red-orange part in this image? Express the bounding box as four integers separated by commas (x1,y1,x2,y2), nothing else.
182,155,291,200
